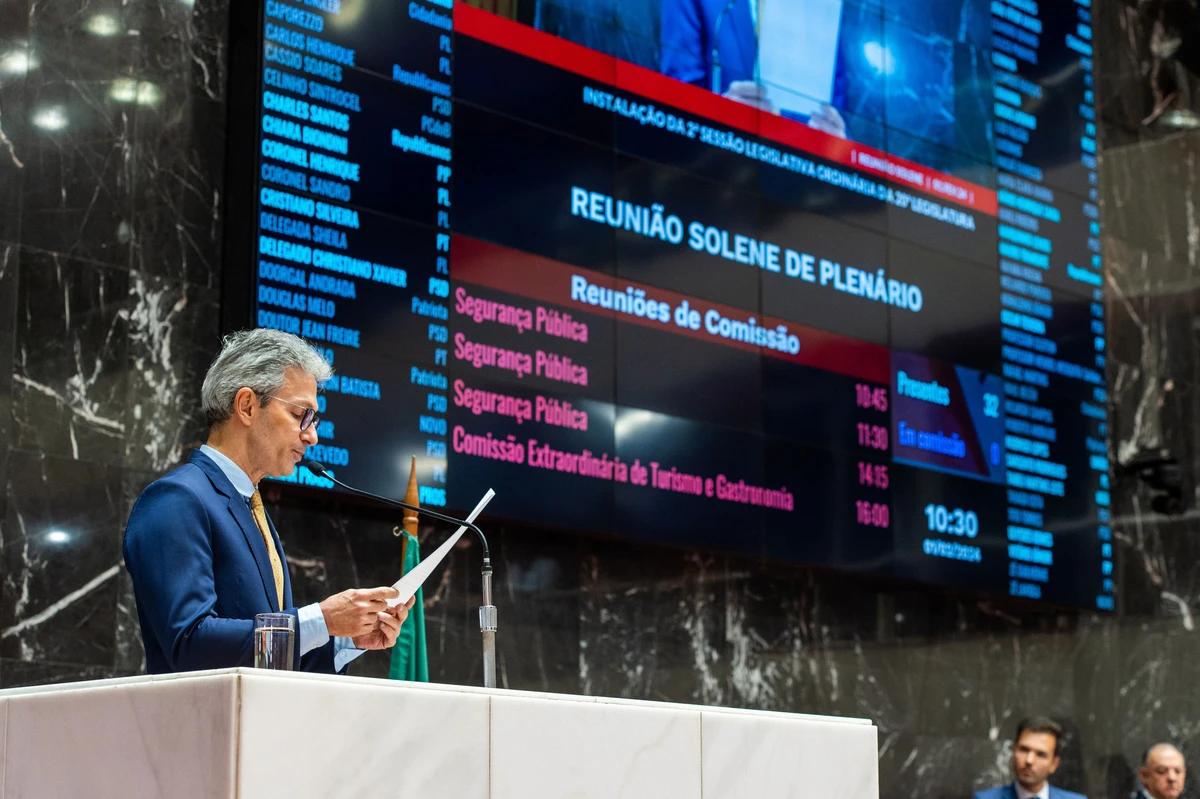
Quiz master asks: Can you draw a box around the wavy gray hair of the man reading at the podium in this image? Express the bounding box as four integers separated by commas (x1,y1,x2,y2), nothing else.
200,328,334,426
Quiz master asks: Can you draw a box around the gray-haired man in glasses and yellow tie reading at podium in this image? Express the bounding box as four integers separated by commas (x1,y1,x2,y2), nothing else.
124,329,412,674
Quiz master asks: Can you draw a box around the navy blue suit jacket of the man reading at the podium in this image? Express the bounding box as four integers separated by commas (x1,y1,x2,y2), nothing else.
124,450,334,674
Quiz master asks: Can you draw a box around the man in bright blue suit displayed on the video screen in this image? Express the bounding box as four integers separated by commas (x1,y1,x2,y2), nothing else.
659,0,846,138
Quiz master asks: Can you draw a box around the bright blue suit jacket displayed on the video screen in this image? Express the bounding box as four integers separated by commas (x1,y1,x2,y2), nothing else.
659,0,758,94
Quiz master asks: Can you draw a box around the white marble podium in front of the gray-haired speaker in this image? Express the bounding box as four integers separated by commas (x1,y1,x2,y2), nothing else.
0,668,878,799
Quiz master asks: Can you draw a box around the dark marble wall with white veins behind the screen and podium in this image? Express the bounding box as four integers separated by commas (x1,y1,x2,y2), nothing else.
0,0,1200,798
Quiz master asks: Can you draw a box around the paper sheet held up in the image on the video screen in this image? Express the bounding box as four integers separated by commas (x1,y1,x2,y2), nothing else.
750,0,842,116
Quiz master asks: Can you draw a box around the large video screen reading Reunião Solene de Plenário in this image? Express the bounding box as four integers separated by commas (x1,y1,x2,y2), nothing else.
230,0,1114,609
